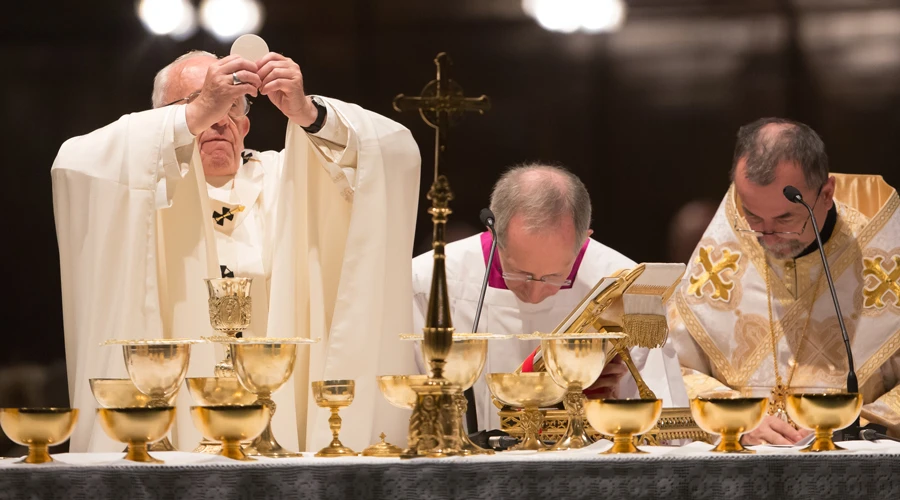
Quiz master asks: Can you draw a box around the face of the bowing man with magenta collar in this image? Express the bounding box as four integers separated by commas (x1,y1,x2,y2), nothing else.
497,216,590,304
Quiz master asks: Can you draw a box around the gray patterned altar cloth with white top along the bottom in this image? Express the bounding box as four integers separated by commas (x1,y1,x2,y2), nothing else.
0,441,900,500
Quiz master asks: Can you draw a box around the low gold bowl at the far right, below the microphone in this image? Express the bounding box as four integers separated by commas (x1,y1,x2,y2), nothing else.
785,389,863,453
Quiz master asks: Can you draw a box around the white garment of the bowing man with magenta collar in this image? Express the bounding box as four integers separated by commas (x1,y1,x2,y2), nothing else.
413,233,687,432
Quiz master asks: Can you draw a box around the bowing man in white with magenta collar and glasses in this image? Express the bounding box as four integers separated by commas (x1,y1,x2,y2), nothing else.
413,164,688,433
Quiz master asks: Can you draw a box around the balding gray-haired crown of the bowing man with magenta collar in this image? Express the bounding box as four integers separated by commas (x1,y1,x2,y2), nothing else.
491,163,591,253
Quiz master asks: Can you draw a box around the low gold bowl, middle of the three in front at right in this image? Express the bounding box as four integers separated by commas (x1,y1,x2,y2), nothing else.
691,393,769,453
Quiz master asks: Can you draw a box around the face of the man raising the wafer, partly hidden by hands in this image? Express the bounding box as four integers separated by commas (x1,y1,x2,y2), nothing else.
166,57,250,177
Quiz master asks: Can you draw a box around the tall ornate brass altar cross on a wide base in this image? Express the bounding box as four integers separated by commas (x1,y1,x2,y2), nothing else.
394,52,491,456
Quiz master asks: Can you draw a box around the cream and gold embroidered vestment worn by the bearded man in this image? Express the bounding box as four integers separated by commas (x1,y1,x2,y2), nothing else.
669,174,900,433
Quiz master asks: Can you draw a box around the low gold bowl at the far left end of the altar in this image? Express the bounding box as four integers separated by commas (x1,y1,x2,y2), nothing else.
0,408,78,464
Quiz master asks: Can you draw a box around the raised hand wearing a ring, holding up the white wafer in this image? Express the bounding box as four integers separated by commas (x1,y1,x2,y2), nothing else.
185,55,260,135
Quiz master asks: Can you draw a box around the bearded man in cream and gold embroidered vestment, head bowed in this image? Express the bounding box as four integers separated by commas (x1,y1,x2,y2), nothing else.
669,118,900,444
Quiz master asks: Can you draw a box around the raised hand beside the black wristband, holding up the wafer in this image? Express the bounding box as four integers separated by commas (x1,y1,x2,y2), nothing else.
256,52,318,127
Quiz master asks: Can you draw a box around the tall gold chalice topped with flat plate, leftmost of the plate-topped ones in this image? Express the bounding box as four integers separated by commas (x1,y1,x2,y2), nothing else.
103,339,203,451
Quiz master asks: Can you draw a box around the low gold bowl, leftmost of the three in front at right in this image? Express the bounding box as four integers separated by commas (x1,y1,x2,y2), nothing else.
584,399,662,455
